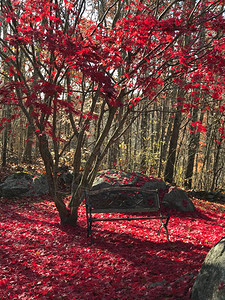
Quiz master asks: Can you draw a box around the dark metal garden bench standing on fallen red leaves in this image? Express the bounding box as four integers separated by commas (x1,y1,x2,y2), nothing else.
85,186,170,244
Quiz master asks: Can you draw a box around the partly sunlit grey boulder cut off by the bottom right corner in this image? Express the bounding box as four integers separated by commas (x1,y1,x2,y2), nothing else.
191,237,225,300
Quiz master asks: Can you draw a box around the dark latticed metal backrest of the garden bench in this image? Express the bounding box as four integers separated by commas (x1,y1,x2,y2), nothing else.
85,186,160,213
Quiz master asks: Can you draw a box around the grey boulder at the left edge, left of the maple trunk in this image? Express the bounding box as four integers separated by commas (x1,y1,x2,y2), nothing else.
0,172,49,198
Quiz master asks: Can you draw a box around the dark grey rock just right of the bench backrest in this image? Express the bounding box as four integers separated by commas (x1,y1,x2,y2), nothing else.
163,187,195,212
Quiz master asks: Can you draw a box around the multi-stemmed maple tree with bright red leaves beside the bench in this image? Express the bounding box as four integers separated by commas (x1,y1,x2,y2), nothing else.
0,0,225,225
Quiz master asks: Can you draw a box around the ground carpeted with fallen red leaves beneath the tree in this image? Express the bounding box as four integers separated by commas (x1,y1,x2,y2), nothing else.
0,199,225,300
